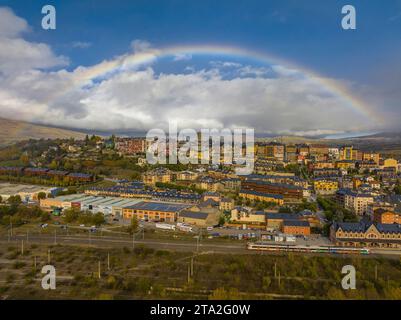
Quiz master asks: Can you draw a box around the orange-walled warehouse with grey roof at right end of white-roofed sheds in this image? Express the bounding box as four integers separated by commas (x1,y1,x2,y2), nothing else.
123,201,192,222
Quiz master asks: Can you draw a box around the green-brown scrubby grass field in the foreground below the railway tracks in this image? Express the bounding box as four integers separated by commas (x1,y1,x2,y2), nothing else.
0,240,401,299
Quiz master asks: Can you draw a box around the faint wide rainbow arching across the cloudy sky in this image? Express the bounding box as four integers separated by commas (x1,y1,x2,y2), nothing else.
57,45,383,124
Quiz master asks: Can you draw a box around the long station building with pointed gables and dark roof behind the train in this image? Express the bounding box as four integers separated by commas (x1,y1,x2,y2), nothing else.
330,222,401,248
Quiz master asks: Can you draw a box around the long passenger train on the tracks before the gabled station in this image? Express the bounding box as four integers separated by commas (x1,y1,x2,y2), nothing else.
247,242,370,255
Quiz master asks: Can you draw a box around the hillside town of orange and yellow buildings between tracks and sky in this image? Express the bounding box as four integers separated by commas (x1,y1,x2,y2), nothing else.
0,136,401,254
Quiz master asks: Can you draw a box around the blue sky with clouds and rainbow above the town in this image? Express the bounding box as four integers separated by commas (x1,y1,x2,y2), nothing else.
0,0,401,136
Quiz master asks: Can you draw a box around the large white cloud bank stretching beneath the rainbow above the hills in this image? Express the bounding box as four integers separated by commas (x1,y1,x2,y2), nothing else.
0,10,376,135
